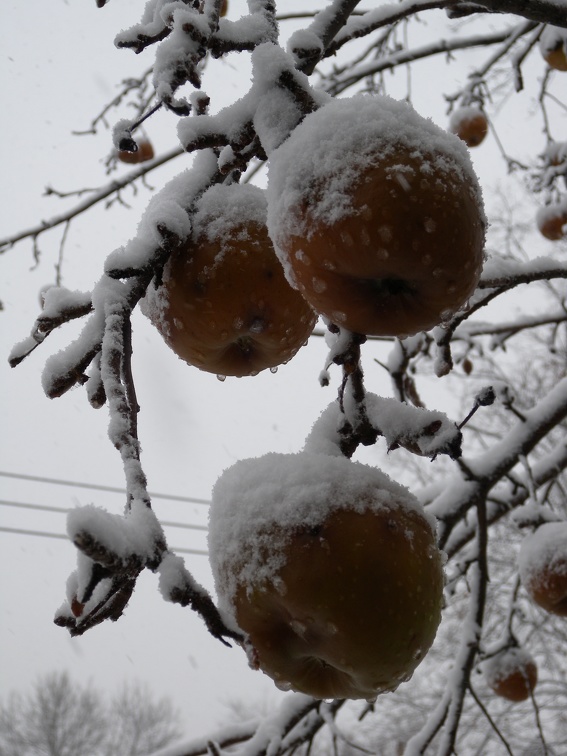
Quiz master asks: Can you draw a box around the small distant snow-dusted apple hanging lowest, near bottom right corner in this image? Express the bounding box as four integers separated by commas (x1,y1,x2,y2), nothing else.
481,646,537,701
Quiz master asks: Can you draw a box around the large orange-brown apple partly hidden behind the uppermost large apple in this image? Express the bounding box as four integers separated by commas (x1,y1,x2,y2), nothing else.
143,184,317,377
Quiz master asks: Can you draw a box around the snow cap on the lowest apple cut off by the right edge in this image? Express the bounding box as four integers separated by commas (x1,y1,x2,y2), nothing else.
518,521,567,585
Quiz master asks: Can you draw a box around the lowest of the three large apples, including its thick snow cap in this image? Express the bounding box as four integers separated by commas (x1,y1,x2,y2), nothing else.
209,452,443,699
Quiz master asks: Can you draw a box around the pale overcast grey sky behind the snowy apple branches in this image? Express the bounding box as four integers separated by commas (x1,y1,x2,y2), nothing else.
0,0,564,733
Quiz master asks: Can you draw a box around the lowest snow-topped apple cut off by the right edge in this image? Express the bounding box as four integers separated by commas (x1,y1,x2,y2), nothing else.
518,521,567,617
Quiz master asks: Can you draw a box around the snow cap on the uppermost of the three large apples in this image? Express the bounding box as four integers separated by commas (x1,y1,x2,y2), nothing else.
268,90,482,285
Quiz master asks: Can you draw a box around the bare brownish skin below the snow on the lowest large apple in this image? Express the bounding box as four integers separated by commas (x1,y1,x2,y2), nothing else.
236,510,443,699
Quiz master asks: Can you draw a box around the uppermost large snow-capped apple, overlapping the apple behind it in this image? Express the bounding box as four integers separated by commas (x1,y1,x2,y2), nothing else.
268,95,486,337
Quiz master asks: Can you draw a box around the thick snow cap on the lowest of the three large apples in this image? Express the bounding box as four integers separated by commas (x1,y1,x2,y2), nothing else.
209,451,435,616
